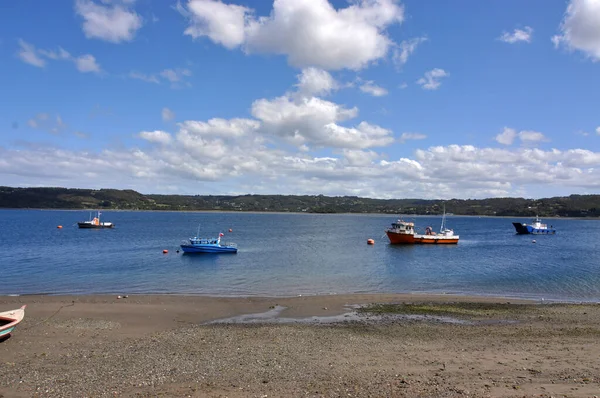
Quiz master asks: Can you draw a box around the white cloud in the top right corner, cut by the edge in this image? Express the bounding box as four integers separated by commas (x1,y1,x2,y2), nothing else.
552,0,600,61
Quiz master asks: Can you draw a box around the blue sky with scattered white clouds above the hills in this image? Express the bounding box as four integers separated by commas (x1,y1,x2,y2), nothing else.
0,0,600,199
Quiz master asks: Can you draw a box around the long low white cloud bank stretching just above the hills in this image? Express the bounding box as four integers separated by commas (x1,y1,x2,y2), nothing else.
0,142,600,199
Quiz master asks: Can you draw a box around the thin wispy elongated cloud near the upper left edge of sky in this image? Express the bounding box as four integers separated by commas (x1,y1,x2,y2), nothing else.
17,39,102,73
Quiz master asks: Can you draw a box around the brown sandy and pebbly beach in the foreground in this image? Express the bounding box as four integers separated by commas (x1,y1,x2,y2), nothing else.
0,294,600,398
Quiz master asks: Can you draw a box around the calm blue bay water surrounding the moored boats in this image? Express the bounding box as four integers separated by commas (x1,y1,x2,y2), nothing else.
0,210,600,301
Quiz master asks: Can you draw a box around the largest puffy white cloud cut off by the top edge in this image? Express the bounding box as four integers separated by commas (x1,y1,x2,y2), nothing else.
180,0,404,70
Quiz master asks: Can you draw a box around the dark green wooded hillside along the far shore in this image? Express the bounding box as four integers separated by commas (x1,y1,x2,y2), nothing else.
0,187,600,217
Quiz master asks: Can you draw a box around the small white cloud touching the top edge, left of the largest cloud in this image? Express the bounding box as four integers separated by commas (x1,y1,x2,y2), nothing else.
75,0,142,43
